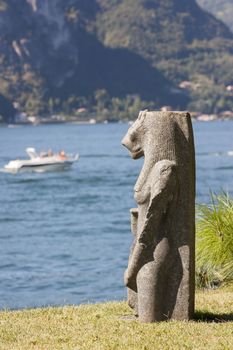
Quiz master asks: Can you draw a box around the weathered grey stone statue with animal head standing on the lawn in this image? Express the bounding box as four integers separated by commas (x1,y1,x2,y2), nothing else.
122,111,195,322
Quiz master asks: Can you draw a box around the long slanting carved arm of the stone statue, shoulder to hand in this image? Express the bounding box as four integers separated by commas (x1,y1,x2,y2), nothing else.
125,160,177,291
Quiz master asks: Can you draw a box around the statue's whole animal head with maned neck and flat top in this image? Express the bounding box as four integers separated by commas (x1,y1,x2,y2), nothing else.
122,110,193,174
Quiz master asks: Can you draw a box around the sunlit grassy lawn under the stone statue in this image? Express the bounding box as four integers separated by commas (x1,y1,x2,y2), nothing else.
0,286,233,350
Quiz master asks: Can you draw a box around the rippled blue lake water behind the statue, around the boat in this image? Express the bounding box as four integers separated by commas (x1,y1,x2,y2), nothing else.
0,121,233,308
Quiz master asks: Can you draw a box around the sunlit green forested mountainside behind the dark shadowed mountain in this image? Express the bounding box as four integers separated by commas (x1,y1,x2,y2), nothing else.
96,0,233,112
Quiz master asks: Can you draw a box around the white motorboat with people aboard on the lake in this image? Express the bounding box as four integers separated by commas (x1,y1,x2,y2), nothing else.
4,147,79,174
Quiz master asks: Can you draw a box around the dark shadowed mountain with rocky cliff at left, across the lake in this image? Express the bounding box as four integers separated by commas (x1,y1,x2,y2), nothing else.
0,0,187,119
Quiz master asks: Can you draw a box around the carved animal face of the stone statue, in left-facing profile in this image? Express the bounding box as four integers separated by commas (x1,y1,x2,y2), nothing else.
121,112,145,159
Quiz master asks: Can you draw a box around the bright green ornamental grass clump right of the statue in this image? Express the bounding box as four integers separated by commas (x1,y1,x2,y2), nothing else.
196,192,233,288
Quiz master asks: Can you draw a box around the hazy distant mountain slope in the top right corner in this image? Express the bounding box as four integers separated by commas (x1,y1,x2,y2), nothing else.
198,0,233,32
